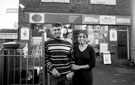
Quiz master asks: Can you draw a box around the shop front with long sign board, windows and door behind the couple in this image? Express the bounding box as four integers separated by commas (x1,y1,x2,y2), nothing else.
20,12,131,64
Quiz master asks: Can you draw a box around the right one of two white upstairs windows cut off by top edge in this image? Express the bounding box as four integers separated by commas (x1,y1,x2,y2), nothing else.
90,0,116,5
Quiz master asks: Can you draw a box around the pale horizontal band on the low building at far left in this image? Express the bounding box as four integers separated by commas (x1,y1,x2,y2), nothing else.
0,33,17,39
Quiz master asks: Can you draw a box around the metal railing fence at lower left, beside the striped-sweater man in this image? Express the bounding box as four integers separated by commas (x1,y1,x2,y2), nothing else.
0,49,46,85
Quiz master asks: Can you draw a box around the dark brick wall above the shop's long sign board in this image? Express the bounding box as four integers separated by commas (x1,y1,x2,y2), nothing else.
20,0,131,16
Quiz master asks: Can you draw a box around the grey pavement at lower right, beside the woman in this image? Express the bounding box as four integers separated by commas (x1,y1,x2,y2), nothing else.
93,63,135,85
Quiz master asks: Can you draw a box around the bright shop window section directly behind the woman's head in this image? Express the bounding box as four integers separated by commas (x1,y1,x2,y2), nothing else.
73,25,108,55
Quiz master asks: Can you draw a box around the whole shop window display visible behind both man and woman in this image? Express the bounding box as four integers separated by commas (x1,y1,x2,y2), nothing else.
33,24,108,54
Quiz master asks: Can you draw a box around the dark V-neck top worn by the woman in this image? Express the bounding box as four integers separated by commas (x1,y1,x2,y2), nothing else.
74,45,95,70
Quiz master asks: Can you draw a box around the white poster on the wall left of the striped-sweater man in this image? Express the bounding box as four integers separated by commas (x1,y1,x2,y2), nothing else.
21,27,30,40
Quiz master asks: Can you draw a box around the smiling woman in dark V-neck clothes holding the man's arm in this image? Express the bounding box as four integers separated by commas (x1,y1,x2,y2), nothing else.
72,32,95,85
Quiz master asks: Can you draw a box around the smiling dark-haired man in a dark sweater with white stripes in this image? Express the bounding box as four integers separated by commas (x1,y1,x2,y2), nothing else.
45,23,74,85
